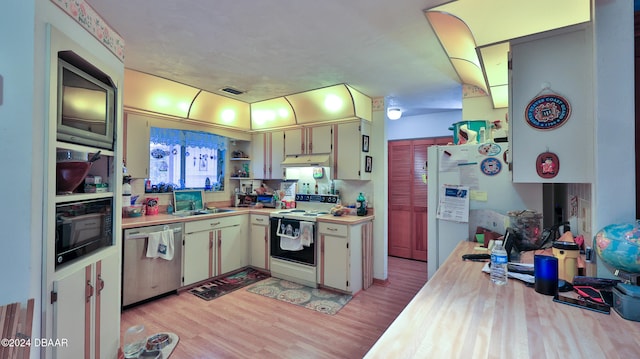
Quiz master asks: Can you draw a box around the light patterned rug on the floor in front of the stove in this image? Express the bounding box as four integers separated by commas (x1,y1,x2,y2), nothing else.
247,278,352,315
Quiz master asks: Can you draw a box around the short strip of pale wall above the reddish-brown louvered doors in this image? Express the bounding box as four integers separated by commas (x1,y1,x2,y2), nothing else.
382,109,462,141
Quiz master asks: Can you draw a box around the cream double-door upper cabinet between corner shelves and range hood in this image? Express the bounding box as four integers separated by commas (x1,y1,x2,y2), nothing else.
251,131,284,179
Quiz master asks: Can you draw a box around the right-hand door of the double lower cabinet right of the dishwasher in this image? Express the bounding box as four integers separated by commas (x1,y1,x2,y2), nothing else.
216,225,247,275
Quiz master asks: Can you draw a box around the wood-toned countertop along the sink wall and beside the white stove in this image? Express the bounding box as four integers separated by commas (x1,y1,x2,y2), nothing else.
122,207,374,229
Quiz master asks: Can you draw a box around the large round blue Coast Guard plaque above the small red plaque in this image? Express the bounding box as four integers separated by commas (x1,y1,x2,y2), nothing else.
524,94,571,130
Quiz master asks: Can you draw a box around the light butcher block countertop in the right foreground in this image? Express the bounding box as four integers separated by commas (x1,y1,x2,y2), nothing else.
366,241,640,359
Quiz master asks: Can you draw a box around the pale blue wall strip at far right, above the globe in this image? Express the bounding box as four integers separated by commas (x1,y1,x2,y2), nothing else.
592,0,636,276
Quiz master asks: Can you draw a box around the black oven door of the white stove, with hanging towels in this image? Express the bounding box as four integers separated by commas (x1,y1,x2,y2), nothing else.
269,218,316,266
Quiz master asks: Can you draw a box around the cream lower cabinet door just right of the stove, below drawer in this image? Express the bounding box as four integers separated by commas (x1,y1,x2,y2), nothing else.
320,234,349,291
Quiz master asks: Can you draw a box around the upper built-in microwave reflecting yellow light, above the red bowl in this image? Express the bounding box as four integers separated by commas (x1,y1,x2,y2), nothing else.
57,51,116,150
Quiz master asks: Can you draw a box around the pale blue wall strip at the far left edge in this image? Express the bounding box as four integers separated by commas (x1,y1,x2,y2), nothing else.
0,0,36,305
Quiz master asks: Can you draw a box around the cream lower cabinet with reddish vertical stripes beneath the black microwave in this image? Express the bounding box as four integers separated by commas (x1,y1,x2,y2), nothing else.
51,252,120,359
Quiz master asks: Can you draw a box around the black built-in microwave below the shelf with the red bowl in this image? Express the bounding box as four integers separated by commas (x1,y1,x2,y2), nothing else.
55,198,114,267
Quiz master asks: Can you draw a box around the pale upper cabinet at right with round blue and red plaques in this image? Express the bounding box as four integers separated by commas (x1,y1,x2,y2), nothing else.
509,25,594,183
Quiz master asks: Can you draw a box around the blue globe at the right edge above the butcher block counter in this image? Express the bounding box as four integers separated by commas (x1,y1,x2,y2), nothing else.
596,221,640,273
